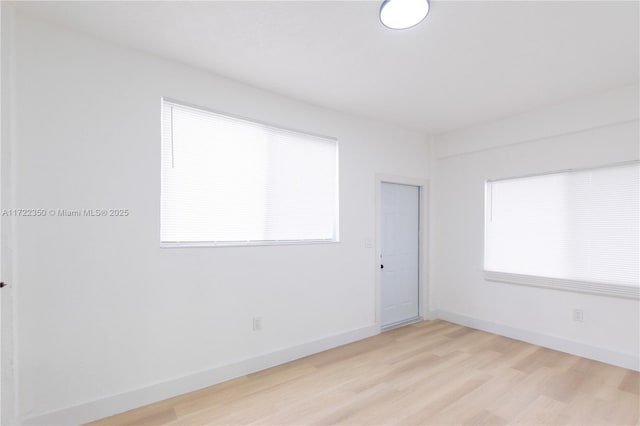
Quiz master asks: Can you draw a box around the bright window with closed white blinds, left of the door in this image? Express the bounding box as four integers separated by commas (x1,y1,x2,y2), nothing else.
160,100,338,246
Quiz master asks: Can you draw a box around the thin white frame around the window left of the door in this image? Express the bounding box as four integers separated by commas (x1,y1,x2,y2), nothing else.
158,96,340,248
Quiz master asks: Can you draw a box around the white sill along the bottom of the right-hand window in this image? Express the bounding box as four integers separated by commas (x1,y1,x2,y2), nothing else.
484,270,640,299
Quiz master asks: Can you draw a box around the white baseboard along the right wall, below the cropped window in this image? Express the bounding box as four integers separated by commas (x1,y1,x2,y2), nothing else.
437,310,640,371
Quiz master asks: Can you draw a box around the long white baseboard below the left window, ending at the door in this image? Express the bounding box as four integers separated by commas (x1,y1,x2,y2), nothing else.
21,325,379,426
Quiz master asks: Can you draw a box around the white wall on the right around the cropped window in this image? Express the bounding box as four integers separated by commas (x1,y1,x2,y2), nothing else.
431,86,640,369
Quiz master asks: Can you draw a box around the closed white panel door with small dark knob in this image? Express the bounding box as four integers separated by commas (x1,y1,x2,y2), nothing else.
380,182,420,327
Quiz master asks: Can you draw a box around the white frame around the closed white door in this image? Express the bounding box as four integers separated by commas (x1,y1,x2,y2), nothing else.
374,174,431,332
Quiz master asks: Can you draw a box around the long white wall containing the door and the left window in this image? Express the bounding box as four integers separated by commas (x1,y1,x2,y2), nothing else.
5,14,429,423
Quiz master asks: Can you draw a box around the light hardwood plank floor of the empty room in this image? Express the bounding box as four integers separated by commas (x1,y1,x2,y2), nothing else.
91,321,640,425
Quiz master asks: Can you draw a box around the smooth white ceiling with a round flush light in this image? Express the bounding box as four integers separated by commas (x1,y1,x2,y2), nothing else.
15,1,640,133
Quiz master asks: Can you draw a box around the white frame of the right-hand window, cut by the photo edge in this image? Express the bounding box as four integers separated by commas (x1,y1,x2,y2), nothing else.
482,160,640,300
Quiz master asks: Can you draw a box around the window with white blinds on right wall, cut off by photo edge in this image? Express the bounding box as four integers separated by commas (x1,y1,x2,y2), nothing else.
484,162,640,298
